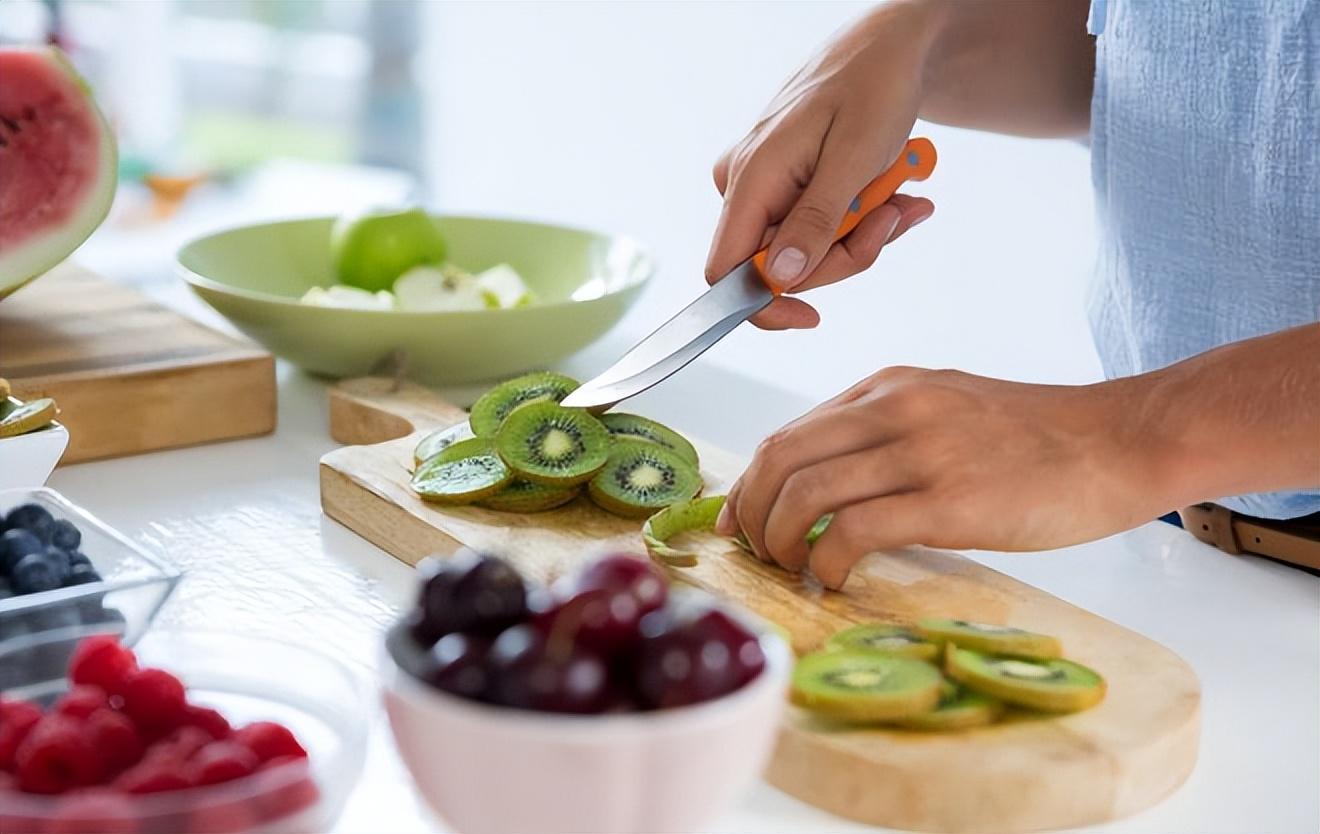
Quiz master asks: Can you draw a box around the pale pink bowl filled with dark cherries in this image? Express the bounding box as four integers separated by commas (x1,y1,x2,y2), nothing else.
381,607,792,834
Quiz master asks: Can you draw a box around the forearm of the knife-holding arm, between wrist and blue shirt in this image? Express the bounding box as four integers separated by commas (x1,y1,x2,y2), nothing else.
894,0,1096,137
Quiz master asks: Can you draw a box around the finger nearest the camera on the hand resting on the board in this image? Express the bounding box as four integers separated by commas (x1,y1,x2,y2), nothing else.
808,491,932,590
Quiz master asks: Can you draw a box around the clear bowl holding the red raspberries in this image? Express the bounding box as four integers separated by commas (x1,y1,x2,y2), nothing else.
0,629,370,834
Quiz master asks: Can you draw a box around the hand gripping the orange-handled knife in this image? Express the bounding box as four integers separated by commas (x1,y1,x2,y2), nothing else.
706,3,940,330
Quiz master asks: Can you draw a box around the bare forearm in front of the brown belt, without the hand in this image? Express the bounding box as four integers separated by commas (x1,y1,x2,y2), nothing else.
1123,323,1320,508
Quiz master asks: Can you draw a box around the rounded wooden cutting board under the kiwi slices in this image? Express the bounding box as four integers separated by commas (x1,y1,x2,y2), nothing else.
321,379,1200,834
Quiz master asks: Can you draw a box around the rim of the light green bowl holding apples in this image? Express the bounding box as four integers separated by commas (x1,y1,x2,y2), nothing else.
174,211,657,318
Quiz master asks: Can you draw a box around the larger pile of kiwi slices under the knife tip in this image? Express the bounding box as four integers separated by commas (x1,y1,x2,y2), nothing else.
412,372,702,519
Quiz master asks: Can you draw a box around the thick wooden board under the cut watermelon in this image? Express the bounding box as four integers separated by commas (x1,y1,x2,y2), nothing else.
0,264,275,463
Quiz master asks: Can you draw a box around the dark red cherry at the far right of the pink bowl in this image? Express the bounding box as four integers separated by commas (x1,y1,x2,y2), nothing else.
634,610,766,709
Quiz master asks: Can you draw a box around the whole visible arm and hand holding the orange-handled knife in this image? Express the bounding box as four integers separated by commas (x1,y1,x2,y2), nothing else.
706,0,1094,329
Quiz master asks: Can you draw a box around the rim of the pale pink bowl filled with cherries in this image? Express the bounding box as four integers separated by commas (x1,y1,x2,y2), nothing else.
379,601,793,739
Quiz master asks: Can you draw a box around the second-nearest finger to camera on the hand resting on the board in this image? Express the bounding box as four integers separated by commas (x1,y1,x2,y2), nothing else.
764,443,916,570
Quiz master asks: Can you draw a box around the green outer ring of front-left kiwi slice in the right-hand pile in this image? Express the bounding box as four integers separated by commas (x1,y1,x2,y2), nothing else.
789,652,944,723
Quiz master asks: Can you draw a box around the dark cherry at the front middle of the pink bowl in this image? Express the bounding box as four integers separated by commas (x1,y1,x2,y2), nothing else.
488,624,616,713
